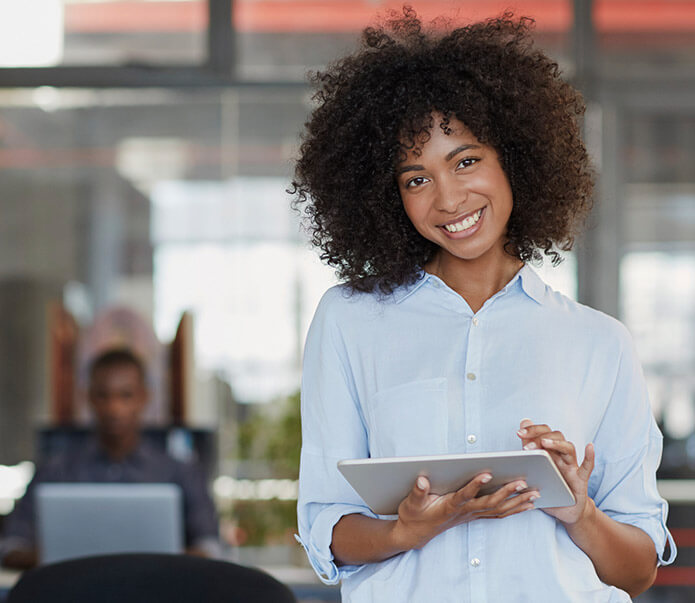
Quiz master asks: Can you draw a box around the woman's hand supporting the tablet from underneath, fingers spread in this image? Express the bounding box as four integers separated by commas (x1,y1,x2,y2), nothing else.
393,473,539,550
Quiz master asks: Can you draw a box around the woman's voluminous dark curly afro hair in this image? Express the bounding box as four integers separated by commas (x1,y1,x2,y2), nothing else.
289,7,593,294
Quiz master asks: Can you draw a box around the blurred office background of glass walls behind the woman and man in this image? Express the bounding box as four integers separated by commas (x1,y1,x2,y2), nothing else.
0,0,695,601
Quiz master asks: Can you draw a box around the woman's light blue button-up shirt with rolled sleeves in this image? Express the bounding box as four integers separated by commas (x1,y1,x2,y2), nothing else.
298,266,675,603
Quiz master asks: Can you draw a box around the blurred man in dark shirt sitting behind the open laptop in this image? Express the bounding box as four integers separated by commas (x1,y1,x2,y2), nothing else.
0,349,219,569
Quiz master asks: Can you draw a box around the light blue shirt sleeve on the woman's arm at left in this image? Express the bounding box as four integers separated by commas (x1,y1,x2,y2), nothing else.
297,288,375,584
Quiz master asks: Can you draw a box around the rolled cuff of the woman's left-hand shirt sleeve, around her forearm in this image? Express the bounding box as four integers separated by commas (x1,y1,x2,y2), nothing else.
295,504,378,585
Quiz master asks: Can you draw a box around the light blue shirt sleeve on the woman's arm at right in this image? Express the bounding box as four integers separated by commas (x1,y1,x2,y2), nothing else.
589,328,676,565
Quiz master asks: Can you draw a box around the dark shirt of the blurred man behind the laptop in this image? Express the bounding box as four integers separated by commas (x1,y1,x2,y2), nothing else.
1,439,218,554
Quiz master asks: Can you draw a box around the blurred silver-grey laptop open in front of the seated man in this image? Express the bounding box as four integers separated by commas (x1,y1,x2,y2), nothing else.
36,483,183,563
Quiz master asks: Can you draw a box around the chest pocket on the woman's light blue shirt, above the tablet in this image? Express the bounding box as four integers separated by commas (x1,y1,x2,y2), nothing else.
367,377,448,457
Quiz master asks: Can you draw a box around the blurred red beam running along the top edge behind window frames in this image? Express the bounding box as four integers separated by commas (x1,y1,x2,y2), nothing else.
65,0,695,33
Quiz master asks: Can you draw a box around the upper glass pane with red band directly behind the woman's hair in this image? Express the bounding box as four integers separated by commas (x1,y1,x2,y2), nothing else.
237,0,572,80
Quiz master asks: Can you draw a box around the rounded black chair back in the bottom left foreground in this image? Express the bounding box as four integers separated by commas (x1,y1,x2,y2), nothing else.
7,553,296,603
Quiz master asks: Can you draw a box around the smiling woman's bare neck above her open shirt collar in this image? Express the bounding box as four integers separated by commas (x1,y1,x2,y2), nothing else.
425,251,524,312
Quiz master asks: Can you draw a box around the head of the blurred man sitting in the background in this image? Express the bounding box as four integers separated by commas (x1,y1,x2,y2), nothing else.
89,349,149,442
